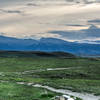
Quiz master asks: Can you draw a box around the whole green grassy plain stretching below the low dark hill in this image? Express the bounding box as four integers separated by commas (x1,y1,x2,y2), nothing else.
0,57,100,100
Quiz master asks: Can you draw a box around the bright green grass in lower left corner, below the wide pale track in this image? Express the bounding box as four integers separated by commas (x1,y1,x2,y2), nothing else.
0,82,56,100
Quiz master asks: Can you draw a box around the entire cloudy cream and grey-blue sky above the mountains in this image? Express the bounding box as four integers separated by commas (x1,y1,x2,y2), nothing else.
0,0,100,41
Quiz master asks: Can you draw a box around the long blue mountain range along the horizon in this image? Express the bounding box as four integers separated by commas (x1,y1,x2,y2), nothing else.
0,36,100,56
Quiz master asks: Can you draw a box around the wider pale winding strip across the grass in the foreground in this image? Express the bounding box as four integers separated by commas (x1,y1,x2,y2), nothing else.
17,82,100,100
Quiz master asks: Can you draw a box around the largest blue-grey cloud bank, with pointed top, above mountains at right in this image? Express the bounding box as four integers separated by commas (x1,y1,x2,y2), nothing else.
49,25,100,40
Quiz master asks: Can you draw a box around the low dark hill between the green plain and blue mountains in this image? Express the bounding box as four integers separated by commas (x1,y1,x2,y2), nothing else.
0,51,76,58
